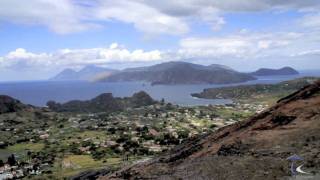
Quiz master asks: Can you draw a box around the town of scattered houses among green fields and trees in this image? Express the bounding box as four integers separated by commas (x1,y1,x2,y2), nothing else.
0,101,268,179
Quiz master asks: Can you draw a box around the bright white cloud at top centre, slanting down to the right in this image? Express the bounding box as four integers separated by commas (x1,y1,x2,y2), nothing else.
95,0,189,35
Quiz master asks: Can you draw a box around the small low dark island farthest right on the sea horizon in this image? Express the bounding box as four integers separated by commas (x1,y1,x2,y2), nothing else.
250,67,299,76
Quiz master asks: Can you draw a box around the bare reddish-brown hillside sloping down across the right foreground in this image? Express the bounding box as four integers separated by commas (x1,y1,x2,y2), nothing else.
100,81,320,180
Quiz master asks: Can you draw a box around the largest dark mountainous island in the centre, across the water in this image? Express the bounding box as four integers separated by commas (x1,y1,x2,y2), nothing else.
102,62,255,85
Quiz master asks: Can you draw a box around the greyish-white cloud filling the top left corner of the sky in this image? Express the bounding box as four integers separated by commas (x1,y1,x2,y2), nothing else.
0,0,99,34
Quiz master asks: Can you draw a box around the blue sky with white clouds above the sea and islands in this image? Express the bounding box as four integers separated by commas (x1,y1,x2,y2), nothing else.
0,0,320,81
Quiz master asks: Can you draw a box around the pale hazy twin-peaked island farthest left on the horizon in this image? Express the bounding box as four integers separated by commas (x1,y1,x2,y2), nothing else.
51,65,117,81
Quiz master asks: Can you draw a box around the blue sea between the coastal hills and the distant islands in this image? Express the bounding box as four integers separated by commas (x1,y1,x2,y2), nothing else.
0,71,320,106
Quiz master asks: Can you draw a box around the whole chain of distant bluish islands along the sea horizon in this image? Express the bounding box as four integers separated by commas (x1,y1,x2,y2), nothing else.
49,61,299,85
